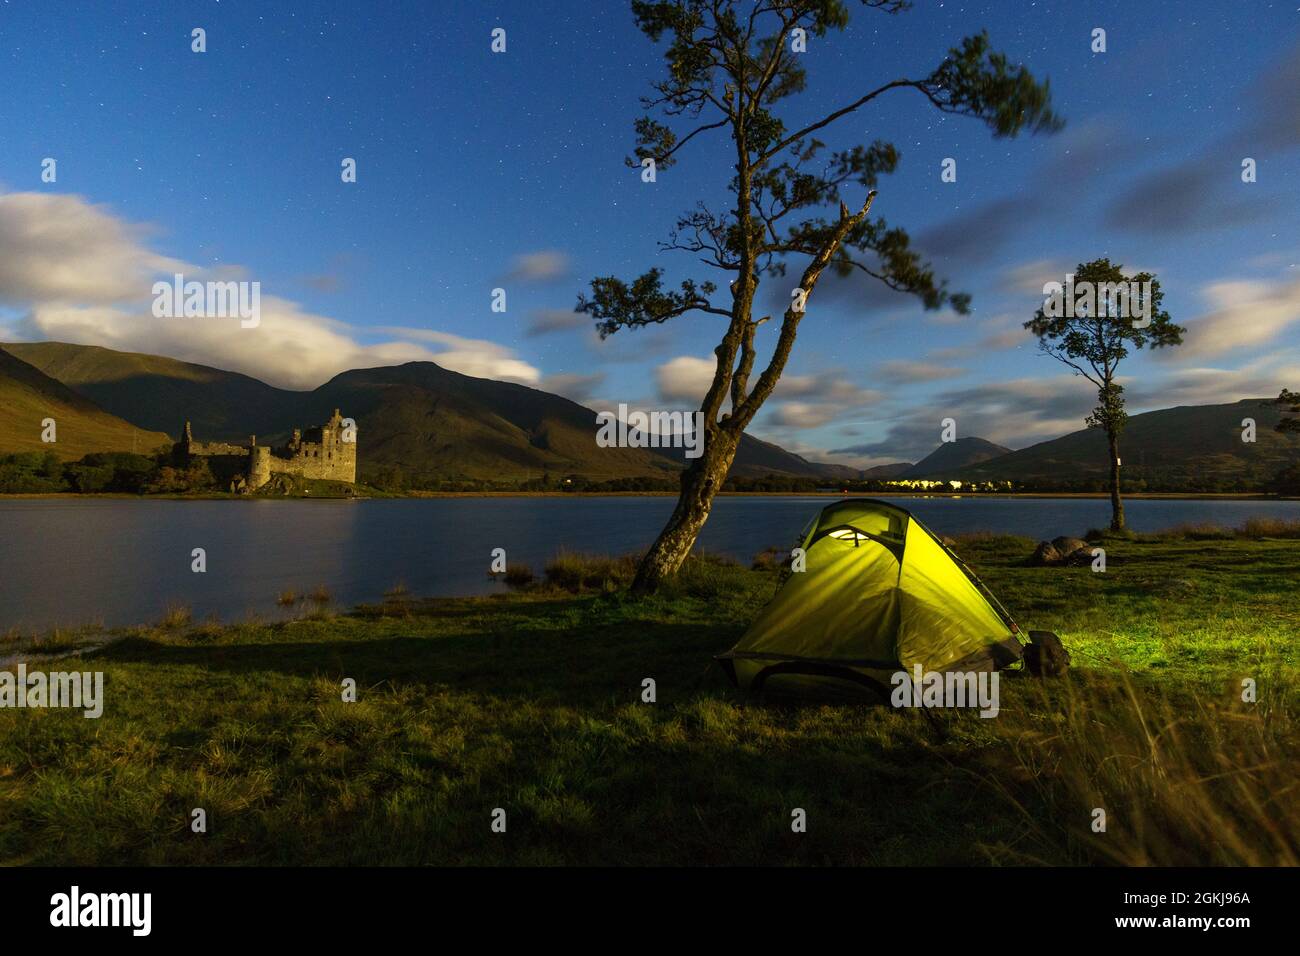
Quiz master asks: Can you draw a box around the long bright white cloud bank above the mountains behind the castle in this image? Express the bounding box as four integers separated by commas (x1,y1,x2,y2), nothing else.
0,193,541,389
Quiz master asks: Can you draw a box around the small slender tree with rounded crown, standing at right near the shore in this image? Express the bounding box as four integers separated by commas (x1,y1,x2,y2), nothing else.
1024,259,1186,531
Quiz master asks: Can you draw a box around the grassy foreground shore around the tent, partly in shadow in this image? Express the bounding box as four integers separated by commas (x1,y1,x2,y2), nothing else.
0,528,1300,865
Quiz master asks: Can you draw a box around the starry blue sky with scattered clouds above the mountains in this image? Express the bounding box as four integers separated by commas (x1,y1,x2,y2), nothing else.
0,0,1300,464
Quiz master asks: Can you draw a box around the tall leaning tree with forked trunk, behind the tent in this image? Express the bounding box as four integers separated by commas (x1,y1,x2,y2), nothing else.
577,0,1061,593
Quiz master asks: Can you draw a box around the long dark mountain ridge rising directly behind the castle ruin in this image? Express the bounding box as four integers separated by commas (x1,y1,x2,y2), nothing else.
0,342,858,480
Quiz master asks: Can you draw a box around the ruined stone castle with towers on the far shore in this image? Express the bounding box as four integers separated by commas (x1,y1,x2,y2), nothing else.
173,408,356,493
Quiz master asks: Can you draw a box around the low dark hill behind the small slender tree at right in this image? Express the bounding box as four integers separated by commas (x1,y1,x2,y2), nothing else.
958,398,1300,489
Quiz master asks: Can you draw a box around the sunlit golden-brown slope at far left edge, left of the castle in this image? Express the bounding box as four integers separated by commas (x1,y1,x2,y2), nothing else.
0,349,170,459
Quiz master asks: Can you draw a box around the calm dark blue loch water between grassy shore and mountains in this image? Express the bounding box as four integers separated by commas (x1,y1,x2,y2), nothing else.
0,497,1300,631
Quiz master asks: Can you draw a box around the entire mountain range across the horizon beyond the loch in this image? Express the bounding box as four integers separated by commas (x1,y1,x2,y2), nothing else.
12,342,1300,490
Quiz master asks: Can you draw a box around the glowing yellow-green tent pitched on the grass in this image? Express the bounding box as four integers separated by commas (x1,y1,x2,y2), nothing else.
718,498,1021,696
